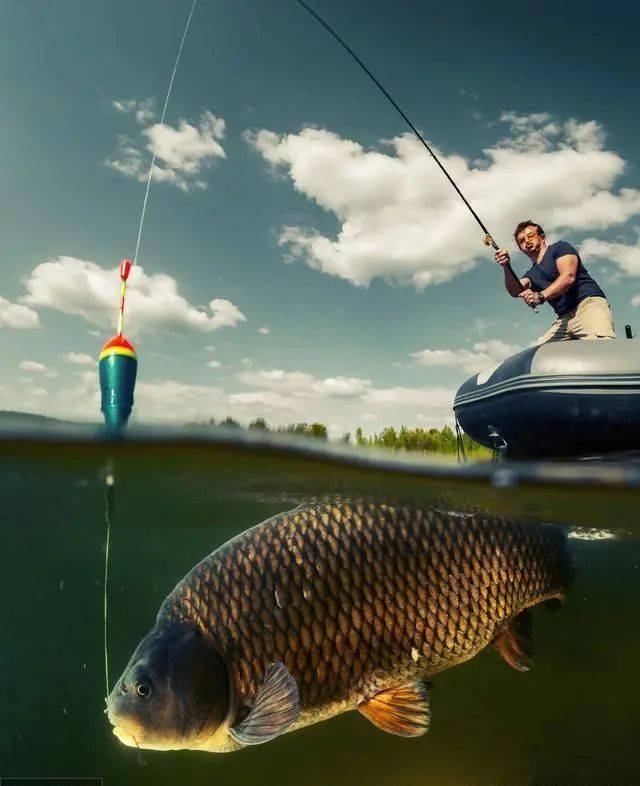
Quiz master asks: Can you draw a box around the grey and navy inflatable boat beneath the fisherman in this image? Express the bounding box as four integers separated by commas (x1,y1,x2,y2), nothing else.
453,339,640,458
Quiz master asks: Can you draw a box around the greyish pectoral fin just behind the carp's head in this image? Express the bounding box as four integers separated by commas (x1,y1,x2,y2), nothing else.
229,663,300,745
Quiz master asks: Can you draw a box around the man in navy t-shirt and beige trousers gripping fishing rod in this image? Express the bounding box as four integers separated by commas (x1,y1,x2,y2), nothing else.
495,221,616,344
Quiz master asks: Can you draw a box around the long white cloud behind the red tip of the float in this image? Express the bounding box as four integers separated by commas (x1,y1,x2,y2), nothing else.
23,256,246,334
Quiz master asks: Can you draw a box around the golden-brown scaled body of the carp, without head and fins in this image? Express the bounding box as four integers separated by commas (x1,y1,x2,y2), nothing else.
158,501,561,725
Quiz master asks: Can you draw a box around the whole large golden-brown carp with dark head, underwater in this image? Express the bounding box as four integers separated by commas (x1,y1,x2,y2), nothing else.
108,500,571,751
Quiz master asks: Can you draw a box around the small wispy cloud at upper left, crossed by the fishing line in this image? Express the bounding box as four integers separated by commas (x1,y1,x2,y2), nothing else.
105,111,227,192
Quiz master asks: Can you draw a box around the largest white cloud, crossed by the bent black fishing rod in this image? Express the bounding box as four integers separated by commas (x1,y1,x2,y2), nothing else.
246,112,640,288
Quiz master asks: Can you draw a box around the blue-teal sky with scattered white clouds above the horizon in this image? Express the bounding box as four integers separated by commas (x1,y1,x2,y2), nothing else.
0,0,640,436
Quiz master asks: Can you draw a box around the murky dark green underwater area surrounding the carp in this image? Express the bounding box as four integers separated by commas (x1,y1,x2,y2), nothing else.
0,434,640,786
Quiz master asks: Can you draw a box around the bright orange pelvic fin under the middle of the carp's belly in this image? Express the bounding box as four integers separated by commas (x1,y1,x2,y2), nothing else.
358,680,431,737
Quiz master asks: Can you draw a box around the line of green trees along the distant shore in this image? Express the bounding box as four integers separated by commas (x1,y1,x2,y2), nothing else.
190,417,489,454
